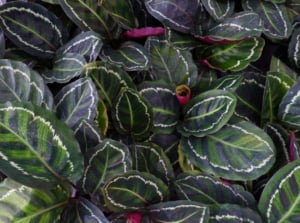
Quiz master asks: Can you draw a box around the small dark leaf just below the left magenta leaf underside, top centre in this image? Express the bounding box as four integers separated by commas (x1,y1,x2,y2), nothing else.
101,41,149,71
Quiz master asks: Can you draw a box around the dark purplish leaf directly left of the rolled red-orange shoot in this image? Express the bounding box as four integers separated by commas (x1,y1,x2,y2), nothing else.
139,81,180,133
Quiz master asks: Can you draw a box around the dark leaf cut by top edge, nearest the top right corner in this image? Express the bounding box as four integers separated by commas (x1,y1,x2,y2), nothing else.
242,0,292,39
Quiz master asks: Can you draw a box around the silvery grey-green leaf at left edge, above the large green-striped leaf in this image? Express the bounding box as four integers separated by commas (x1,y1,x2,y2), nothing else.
0,59,53,110
